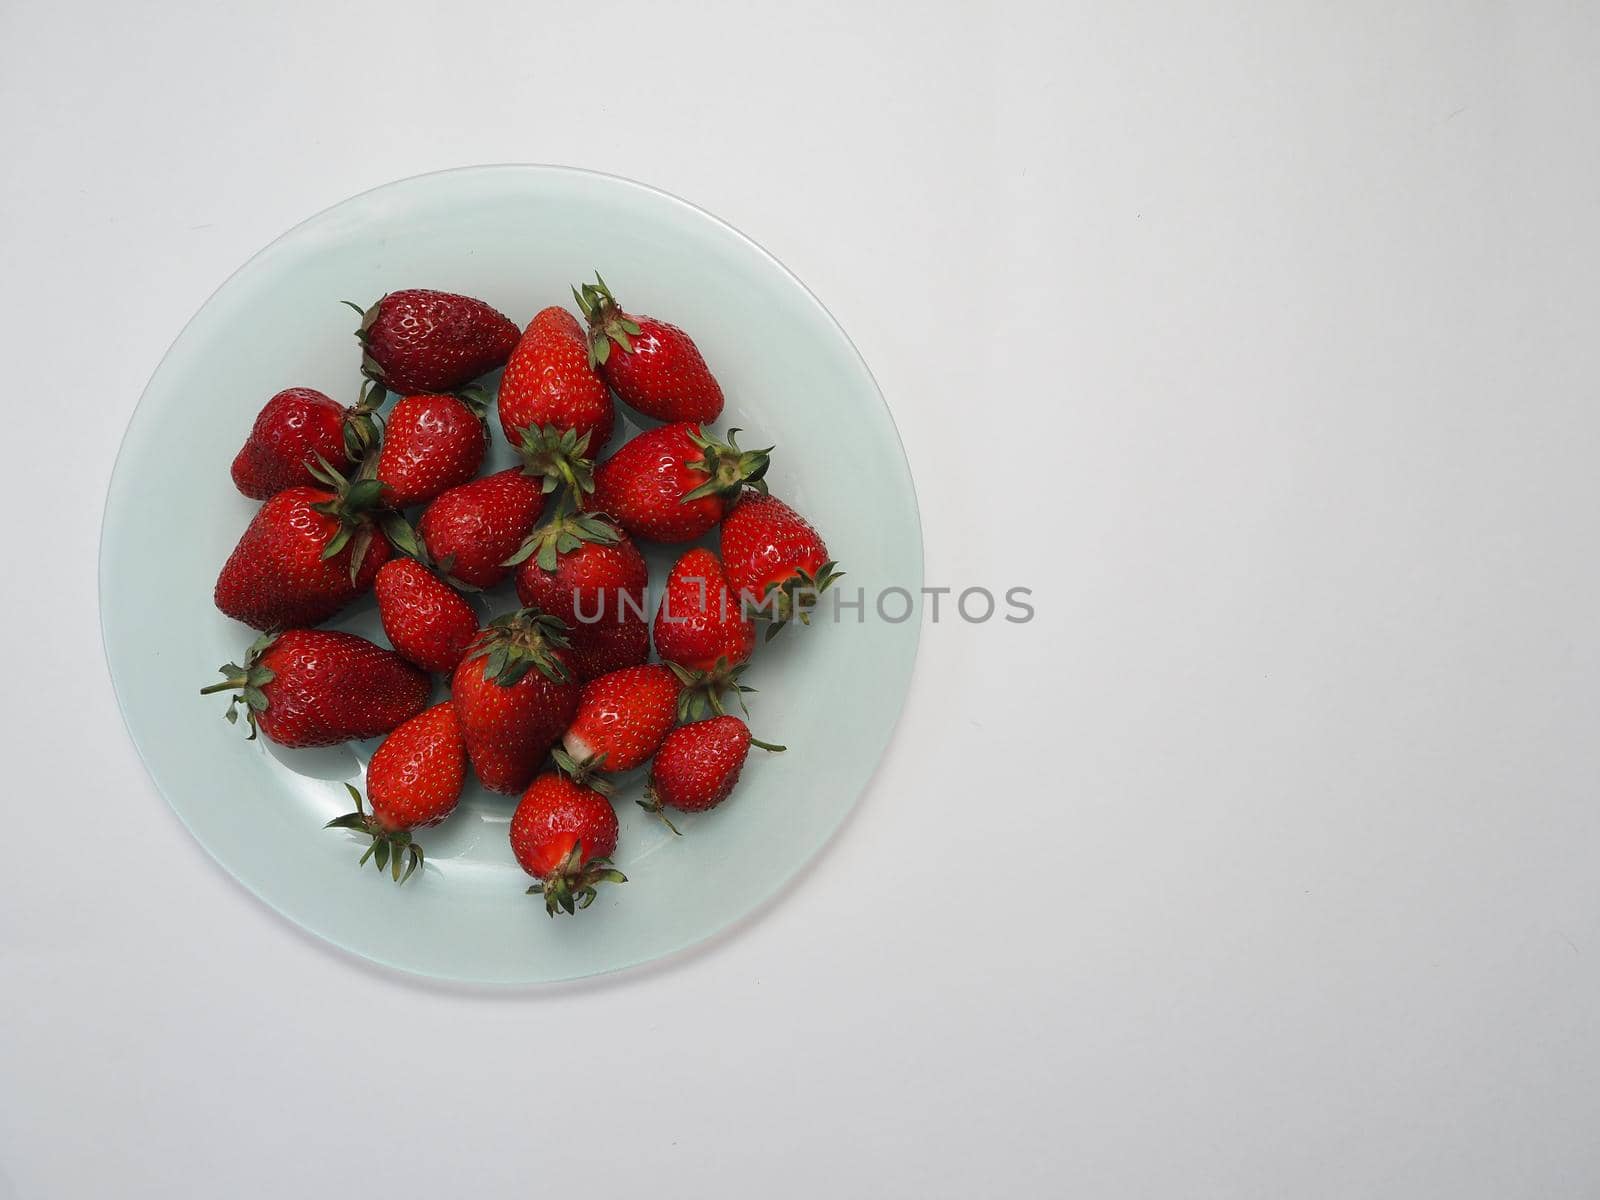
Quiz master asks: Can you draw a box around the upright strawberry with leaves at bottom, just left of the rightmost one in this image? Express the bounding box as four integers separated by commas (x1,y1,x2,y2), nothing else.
654,547,755,717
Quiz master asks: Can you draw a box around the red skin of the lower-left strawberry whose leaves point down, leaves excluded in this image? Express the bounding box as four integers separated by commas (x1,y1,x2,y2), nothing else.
366,701,467,830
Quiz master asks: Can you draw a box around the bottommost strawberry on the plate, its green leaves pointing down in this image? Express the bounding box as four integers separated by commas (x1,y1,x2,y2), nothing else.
510,771,627,917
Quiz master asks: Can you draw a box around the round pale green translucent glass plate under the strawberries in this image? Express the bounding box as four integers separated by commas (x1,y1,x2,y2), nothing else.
101,166,922,984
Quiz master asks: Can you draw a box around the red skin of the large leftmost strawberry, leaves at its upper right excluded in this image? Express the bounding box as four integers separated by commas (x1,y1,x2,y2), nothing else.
213,488,390,629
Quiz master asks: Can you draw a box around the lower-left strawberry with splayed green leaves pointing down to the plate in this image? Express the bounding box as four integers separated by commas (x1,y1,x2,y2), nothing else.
325,701,467,883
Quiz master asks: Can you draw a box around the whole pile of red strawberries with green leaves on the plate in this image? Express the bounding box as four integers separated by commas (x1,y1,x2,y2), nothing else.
205,275,837,915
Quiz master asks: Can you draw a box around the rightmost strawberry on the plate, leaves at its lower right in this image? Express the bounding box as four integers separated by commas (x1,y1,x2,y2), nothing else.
720,493,843,638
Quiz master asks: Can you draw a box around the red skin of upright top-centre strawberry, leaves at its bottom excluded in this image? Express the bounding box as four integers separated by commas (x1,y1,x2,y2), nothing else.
498,307,616,458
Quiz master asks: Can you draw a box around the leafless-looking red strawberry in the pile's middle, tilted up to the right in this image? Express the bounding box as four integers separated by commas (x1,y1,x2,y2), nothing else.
418,467,544,587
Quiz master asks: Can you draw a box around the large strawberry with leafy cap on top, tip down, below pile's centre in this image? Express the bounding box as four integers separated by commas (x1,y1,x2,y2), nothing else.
451,608,579,792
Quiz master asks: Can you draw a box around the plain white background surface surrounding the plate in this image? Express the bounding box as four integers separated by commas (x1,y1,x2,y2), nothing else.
0,0,1600,1200
